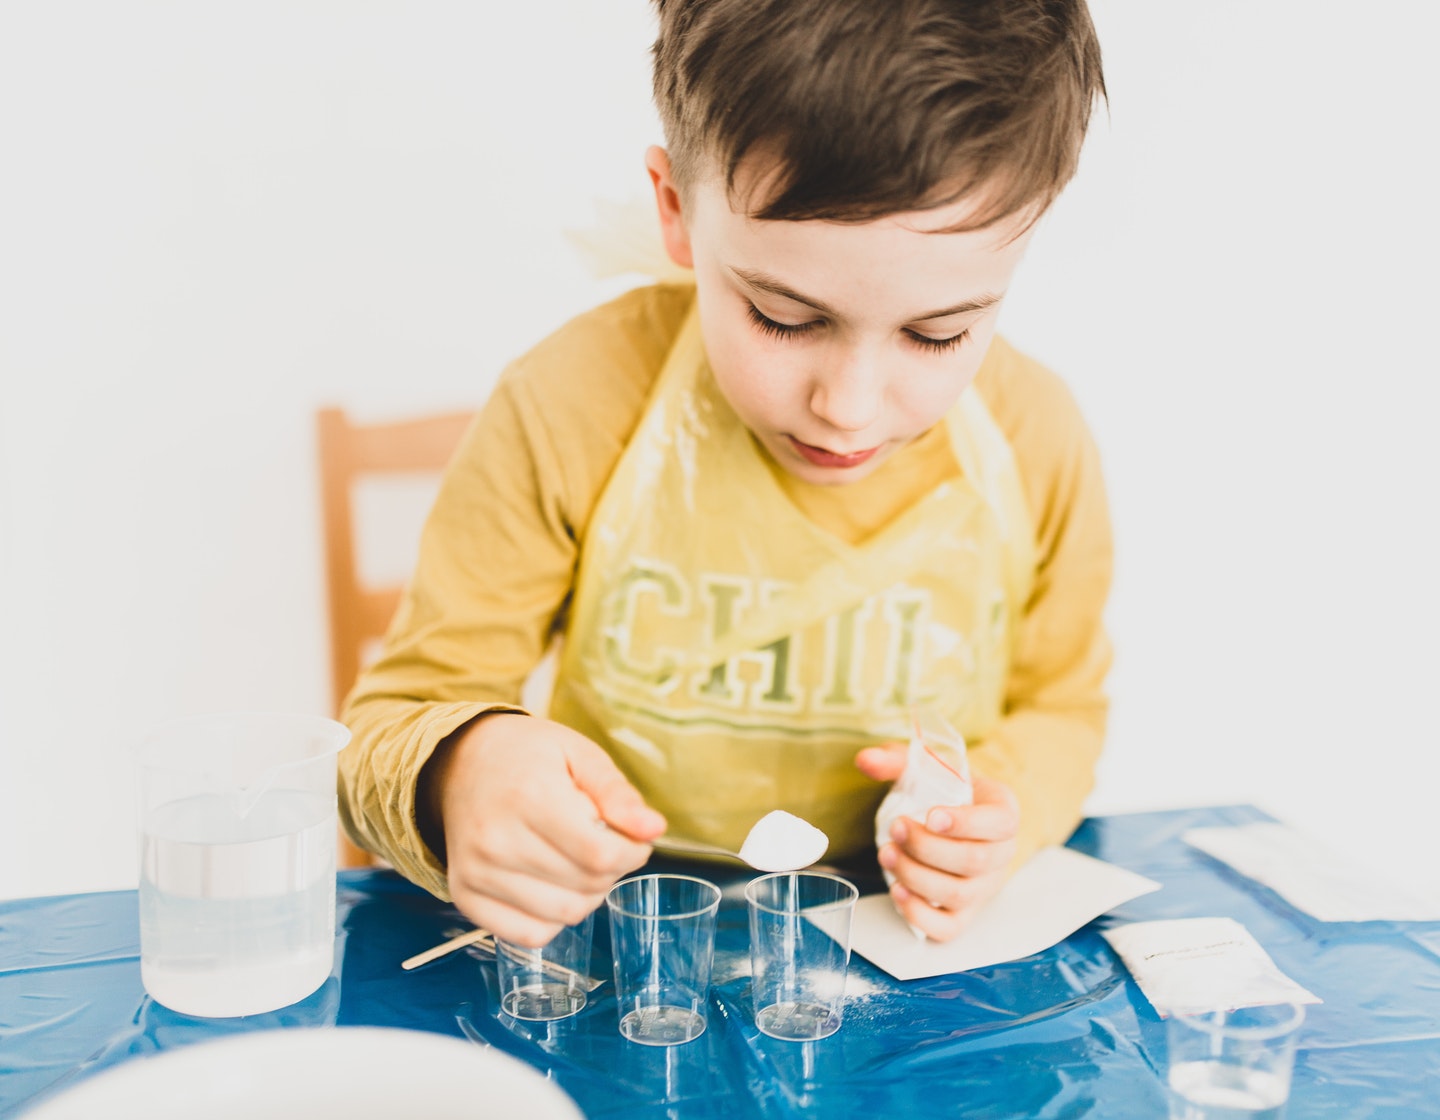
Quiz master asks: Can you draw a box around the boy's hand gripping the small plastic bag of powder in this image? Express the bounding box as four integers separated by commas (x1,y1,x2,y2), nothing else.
855,747,1020,941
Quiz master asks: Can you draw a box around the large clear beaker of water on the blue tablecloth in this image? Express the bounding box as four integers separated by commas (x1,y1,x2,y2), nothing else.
138,713,350,1018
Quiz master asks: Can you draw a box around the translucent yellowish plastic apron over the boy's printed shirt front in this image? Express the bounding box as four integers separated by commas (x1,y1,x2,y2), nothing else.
550,299,1034,858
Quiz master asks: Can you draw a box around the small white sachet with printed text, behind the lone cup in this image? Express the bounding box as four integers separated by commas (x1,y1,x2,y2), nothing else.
1102,918,1322,1019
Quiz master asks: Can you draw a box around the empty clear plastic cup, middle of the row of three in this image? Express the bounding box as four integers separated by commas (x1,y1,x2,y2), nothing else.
605,875,720,1047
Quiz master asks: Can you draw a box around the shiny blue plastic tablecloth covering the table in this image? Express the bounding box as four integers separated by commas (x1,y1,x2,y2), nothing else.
0,806,1440,1120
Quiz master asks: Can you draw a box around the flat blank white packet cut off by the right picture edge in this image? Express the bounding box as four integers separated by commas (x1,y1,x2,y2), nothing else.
1182,821,1440,921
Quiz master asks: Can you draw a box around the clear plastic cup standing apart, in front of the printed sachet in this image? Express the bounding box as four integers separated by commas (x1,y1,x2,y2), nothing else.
1165,1003,1305,1120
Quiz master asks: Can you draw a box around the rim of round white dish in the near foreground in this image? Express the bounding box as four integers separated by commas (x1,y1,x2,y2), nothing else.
24,1026,583,1120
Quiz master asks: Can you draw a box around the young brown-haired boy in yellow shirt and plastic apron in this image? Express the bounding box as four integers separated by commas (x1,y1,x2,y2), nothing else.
341,0,1110,944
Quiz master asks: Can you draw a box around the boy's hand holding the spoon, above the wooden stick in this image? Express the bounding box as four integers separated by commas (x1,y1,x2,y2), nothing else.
426,713,665,946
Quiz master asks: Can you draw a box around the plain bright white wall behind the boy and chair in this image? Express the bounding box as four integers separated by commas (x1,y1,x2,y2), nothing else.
0,0,1440,897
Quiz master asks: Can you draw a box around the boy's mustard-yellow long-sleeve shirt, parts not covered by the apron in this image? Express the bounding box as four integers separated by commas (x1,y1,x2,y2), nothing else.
340,285,1112,897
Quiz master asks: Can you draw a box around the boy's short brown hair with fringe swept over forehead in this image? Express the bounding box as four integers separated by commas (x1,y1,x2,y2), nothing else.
654,0,1104,229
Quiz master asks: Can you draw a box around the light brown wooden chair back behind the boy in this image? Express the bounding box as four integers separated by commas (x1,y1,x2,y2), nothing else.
315,409,474,867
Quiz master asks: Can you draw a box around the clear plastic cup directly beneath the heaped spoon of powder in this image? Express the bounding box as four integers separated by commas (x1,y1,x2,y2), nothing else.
744,871,860,1042
